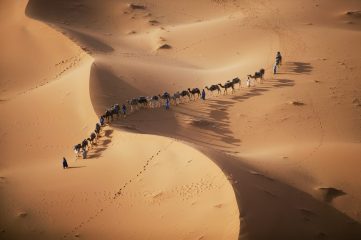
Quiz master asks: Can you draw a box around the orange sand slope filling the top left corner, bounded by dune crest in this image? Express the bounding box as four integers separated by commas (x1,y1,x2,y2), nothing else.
0,0,84,101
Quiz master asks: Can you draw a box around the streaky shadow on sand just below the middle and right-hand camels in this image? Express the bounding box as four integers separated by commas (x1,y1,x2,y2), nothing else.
112,79,294,151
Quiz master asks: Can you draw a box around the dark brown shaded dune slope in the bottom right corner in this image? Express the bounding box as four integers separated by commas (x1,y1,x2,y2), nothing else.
201,148,361,240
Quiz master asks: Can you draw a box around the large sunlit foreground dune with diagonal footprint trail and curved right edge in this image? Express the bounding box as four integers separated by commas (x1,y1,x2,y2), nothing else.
0,0,240,239
